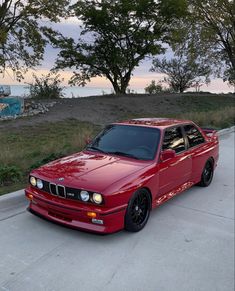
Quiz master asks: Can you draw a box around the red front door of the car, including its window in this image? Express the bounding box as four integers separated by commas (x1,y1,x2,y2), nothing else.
158,126,192,196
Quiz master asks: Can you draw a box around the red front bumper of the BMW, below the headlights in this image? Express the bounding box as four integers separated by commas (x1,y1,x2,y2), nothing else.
25,187,127,233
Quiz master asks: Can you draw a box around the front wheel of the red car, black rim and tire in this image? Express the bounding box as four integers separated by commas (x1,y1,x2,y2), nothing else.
125,189,151,232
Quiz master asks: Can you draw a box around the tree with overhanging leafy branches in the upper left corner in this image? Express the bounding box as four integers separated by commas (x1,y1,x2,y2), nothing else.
0,0,69,80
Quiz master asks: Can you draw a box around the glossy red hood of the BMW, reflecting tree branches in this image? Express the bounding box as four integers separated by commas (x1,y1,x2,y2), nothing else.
32,151,148,193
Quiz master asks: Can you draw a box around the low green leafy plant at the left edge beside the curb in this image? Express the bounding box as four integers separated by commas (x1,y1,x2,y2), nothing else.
0,166,22,186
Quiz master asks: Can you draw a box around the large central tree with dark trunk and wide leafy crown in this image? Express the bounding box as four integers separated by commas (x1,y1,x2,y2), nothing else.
51,0,186,94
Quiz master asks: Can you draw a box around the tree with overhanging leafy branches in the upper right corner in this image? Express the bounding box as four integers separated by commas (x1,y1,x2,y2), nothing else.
173,0,235,84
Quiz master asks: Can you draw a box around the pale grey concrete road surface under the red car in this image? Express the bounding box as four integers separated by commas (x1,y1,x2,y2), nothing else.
0,133,234,291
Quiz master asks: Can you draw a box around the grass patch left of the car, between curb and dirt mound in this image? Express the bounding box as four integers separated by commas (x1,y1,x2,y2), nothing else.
0,120,99,195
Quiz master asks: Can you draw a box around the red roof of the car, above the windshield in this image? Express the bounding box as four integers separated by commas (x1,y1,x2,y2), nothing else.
115,118,192,128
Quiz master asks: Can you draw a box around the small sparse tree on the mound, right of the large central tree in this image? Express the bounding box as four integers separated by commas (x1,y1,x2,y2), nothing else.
151,55,210,93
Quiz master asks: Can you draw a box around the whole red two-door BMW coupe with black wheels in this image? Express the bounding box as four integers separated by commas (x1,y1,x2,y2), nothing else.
25,118,219,233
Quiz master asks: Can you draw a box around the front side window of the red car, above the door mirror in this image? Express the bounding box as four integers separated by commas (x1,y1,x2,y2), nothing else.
162,127,185,153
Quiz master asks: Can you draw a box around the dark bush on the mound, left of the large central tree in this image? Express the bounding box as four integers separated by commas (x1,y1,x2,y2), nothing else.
28,73,64,99
